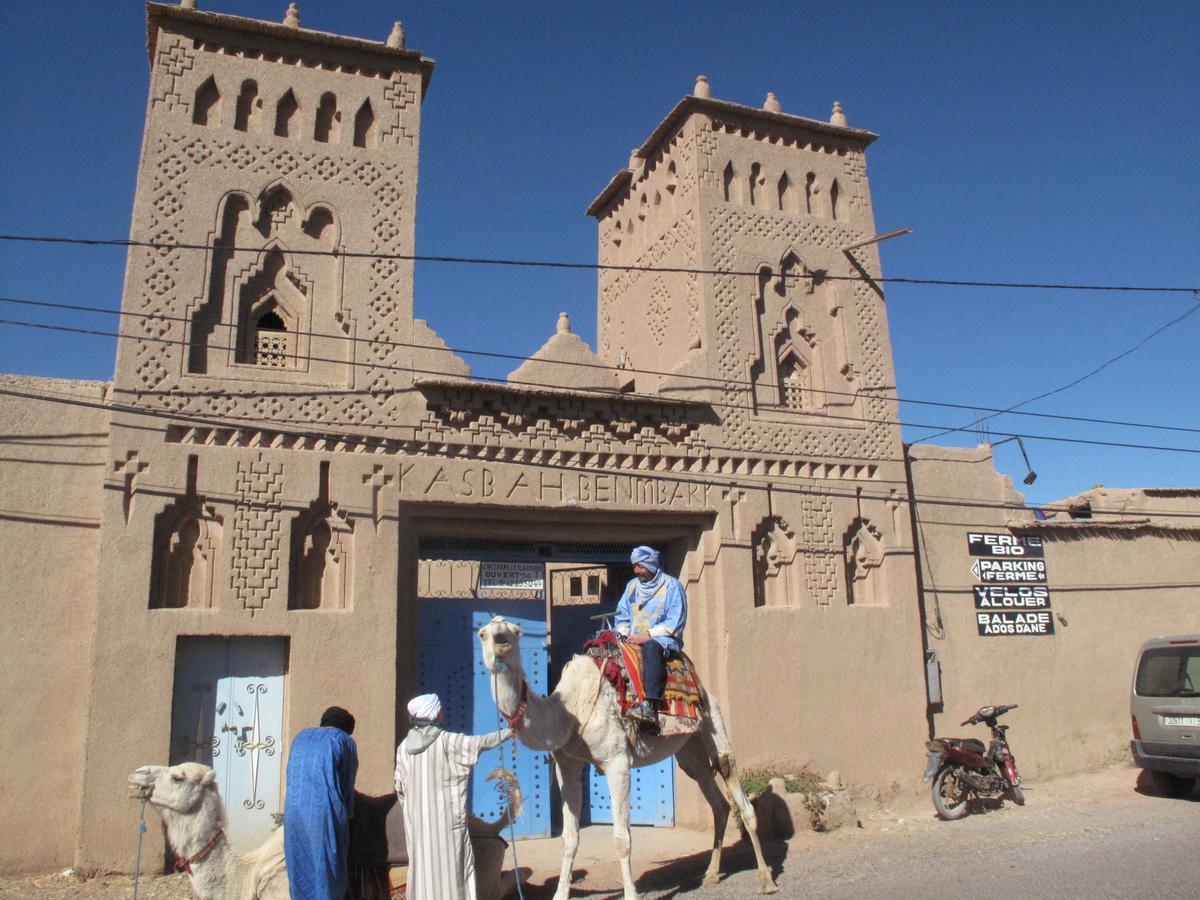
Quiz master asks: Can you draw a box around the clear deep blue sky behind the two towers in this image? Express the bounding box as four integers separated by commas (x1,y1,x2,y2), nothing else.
0,0,1200,503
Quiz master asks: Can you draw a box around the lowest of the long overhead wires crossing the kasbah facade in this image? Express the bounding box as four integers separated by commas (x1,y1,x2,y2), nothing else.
9,388,1200,527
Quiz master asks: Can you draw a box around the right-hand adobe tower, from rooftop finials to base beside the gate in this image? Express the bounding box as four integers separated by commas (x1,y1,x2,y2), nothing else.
588,84,924,801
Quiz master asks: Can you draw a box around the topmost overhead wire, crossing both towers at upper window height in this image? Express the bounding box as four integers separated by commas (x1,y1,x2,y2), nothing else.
0,234,1196,294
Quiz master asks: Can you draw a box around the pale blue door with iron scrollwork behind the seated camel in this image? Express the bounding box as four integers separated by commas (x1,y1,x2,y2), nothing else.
170,637,288,851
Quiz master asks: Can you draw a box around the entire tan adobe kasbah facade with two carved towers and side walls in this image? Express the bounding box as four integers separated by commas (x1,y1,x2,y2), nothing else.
0,0,1200,871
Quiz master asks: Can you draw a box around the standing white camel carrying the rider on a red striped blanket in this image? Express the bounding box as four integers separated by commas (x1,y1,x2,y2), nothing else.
479,616,776,900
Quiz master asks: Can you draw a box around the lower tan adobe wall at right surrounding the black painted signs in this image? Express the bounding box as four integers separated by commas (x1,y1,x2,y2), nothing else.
910,445,1200,779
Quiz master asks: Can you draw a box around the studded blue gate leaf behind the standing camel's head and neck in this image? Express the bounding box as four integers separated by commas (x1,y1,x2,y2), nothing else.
418,599,551,838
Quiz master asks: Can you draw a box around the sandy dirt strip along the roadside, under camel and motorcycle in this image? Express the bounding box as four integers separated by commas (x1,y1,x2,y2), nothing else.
0,764,1180,900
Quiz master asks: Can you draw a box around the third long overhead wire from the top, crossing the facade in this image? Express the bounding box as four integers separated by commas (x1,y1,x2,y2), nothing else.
9,319,1200,454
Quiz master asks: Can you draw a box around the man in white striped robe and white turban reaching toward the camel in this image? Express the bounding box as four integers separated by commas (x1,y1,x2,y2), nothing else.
396,694,512,900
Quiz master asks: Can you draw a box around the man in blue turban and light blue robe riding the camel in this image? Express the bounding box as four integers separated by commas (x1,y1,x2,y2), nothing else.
616,547,688,724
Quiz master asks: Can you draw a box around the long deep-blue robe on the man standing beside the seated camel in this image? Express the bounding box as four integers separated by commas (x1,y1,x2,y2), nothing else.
283,727,359,900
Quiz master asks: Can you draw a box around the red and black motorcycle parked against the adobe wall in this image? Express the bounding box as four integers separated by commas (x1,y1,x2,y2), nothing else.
923,703,1025,821
